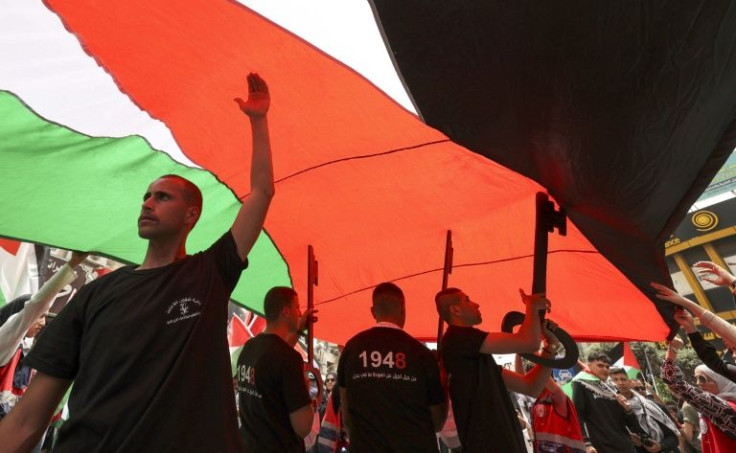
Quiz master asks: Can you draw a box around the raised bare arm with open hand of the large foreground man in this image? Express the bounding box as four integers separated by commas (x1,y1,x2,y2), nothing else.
230,73,275,260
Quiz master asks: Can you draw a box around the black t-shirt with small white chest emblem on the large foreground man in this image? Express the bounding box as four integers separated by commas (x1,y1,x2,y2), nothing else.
26,232,247,453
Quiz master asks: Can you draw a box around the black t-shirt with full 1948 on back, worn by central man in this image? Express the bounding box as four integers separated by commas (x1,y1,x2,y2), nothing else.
337,326,445,453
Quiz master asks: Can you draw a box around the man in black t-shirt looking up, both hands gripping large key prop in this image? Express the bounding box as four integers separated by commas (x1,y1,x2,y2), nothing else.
435,288,556,453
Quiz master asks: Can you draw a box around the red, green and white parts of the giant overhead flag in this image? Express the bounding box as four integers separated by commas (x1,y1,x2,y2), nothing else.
0,0,688,343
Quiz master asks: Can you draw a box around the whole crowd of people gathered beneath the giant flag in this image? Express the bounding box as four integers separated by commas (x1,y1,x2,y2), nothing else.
0,73,736,453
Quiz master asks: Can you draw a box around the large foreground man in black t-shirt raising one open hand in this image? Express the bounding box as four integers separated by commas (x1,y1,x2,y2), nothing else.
0,74,274,453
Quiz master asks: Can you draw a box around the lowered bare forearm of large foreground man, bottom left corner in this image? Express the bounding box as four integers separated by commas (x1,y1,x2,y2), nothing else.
0,373,72,453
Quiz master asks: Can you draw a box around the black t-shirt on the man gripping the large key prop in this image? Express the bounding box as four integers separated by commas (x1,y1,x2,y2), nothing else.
442,326,526,453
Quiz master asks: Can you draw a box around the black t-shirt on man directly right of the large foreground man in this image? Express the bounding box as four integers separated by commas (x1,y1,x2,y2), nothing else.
237,333,311,453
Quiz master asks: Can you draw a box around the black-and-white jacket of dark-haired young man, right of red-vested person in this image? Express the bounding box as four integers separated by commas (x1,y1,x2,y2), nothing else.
572,380,641,453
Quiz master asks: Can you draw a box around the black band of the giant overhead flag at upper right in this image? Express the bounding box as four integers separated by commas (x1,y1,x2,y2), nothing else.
371,0,736,328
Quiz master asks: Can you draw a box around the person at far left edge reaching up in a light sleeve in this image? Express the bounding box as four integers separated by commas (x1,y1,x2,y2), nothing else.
0,252,87,420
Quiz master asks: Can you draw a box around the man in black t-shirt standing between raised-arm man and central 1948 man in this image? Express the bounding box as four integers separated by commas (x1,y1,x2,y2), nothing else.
237,287,314,453
